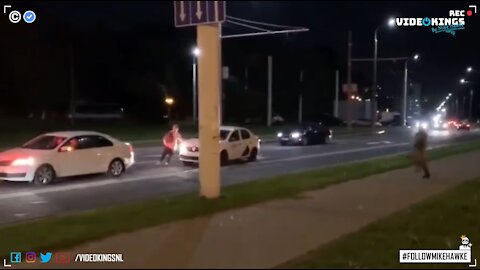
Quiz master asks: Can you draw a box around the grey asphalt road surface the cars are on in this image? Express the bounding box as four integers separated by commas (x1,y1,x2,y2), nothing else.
0,127,480,224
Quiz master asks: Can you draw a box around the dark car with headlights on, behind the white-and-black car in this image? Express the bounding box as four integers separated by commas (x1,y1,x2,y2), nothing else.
277,122,332,145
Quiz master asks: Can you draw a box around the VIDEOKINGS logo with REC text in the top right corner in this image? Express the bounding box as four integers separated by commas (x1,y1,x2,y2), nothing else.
395,5,477,36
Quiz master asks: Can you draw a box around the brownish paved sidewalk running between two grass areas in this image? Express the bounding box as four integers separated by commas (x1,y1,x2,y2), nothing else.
22,151,480,269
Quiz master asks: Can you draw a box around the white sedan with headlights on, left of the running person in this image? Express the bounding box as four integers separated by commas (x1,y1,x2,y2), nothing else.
0,131,135,185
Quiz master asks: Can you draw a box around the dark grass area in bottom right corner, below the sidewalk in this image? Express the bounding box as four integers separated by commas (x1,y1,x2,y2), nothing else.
279,178,480,269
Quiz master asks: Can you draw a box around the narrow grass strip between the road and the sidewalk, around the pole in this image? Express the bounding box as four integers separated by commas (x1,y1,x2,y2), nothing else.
0,141,480,256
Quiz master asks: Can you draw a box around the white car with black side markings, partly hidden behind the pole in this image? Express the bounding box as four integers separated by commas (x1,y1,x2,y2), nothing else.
179,126,260,165
